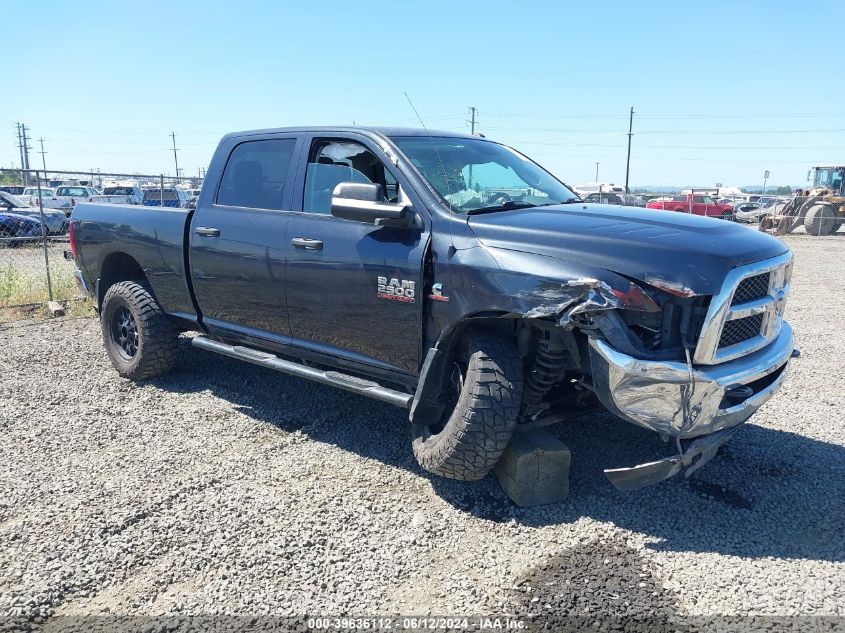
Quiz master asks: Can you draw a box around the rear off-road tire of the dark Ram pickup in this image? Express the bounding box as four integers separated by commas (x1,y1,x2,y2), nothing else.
100,281,179,380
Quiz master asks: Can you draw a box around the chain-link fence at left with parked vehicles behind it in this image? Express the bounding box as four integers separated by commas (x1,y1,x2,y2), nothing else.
0,169,201,321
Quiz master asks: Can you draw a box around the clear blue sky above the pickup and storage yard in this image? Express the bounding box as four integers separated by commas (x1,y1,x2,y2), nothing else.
0,0,845,186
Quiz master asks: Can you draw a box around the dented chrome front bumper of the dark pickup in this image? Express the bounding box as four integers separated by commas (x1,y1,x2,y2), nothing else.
590,323,794,439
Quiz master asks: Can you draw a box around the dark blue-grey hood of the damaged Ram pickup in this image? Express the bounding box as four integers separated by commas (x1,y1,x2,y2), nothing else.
468,204,789,294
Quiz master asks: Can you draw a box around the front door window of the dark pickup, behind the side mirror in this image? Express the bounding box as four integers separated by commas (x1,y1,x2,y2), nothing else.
302,140,399,214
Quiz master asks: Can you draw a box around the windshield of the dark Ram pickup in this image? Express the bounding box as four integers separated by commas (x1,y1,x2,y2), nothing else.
391,136,580,215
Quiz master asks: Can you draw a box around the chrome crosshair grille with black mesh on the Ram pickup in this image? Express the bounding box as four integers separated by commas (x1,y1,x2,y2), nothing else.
694,253,792,365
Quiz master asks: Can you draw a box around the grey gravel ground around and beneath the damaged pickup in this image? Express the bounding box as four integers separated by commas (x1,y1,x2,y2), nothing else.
0,236,845,630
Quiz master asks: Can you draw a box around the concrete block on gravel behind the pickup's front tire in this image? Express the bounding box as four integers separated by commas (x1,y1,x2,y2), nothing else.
493,429,572,508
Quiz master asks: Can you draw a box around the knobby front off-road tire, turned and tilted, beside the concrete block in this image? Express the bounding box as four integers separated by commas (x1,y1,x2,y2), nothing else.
413,331,522,481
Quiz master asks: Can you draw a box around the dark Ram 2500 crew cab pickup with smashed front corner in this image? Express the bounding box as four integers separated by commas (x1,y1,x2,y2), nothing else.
70,127,793,489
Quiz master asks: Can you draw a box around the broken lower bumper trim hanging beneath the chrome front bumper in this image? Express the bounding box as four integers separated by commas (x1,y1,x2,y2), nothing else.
604,425,742,490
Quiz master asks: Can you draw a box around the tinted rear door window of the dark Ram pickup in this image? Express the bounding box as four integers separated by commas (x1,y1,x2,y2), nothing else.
217,138,296,209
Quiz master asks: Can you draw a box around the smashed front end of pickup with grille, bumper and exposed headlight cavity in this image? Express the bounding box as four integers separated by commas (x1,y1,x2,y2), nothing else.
512,253,794,490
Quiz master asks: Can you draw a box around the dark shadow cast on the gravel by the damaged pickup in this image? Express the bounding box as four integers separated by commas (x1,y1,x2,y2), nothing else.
162,341,845,562
